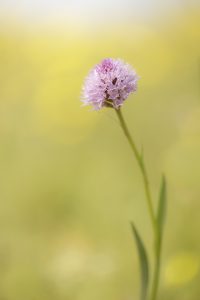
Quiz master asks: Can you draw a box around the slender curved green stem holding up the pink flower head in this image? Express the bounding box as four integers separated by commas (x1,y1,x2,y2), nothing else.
115,109,161,300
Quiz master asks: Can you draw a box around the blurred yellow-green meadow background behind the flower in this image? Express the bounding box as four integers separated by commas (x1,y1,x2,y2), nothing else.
0,0,200,300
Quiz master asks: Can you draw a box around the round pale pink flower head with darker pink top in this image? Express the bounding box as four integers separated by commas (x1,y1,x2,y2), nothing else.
82,58,139,110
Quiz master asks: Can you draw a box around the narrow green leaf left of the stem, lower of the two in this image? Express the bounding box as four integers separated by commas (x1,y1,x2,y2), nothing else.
131,222,149,300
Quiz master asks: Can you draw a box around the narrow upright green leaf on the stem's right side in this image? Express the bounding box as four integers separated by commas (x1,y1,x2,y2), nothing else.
157,176,167,236
